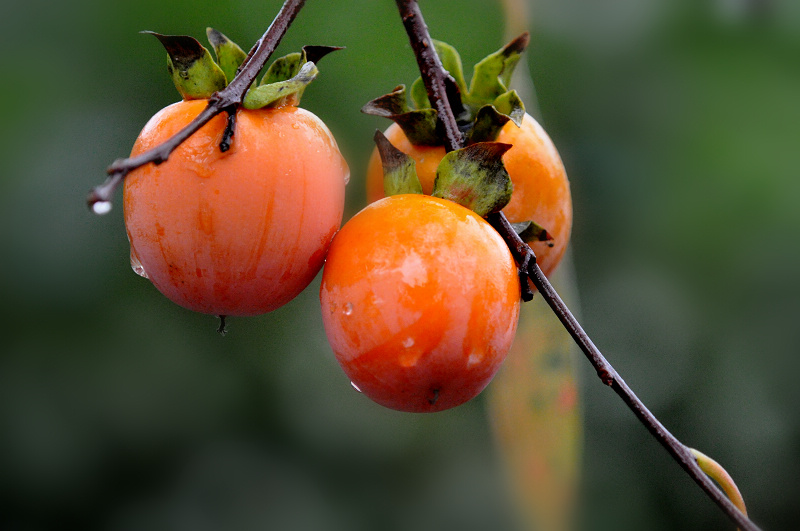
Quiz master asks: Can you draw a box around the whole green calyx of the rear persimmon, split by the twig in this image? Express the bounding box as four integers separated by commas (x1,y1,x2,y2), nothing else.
361,33,530,146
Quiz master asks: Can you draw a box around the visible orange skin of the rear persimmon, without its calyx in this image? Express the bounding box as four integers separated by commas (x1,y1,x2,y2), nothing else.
367,114,572,275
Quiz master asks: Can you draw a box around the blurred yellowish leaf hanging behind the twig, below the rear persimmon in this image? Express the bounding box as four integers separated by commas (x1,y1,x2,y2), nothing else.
488,260,582,531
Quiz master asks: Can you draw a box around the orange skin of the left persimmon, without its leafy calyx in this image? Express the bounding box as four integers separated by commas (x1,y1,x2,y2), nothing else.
124,100,347,315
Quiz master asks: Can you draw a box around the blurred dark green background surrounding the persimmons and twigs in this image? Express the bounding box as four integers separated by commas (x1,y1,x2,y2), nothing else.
0,0,800,531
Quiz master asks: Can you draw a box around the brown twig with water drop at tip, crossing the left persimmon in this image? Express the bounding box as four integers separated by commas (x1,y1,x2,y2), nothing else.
86,0,306,213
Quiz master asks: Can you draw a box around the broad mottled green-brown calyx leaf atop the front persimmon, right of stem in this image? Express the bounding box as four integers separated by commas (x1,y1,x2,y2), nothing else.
431,142,514,216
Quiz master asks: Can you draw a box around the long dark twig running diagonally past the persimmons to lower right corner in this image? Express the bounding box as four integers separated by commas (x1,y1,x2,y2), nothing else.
395,0,759,531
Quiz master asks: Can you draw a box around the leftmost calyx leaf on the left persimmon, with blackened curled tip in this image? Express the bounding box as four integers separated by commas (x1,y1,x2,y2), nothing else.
142,31,227,100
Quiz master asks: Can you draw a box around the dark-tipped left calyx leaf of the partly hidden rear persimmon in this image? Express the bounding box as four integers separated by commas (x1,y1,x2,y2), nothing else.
361,85,443,146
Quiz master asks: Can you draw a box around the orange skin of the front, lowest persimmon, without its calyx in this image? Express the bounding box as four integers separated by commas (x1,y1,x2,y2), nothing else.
320,195,520,412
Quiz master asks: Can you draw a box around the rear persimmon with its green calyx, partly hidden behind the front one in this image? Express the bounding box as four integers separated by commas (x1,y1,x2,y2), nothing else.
362,34,572,274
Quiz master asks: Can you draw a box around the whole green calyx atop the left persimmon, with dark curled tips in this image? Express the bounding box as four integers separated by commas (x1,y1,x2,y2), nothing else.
142,28,342,109
